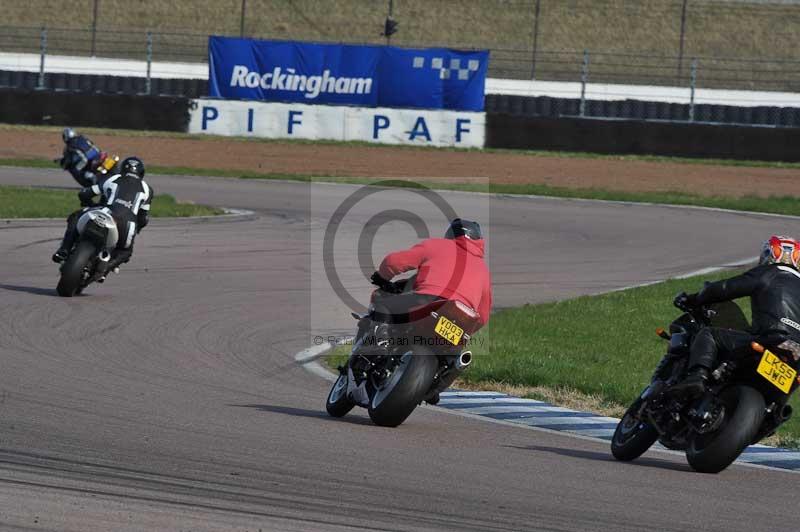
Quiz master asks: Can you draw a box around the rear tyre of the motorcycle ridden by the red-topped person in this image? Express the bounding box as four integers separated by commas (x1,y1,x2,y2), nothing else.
368,348,439,427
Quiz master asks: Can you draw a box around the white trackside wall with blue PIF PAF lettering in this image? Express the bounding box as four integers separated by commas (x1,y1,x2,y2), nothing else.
189,99,486,148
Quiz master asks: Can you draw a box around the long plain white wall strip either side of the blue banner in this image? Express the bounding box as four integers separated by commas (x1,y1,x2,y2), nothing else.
0,53,800,107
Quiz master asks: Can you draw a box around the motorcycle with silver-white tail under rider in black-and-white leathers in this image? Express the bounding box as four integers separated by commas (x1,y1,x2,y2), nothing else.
56,207,119,297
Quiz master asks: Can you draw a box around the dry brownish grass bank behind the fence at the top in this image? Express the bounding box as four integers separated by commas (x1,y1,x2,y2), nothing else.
6,0,800,90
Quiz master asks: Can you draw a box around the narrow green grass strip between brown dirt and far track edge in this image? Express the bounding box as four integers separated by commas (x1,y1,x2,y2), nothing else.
0,159,800,216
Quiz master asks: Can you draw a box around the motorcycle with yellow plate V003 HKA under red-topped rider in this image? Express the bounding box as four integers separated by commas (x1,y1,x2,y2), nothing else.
325,279,480,427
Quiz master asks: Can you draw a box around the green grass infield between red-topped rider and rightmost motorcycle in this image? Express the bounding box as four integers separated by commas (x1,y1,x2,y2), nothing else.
327,271,800,448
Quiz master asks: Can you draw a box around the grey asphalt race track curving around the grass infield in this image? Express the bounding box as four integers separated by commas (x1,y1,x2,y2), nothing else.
0,168,800,531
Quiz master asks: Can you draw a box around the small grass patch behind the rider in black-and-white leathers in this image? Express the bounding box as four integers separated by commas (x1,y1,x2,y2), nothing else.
0,186,223,218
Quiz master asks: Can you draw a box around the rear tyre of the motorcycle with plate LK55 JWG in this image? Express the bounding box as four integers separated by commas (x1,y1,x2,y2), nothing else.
686,386,766,473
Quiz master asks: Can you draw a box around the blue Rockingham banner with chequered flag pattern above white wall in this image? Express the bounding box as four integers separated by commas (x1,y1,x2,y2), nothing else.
208,36,489,111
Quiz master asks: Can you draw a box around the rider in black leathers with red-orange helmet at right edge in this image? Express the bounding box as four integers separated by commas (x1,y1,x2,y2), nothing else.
671,236,800,397
